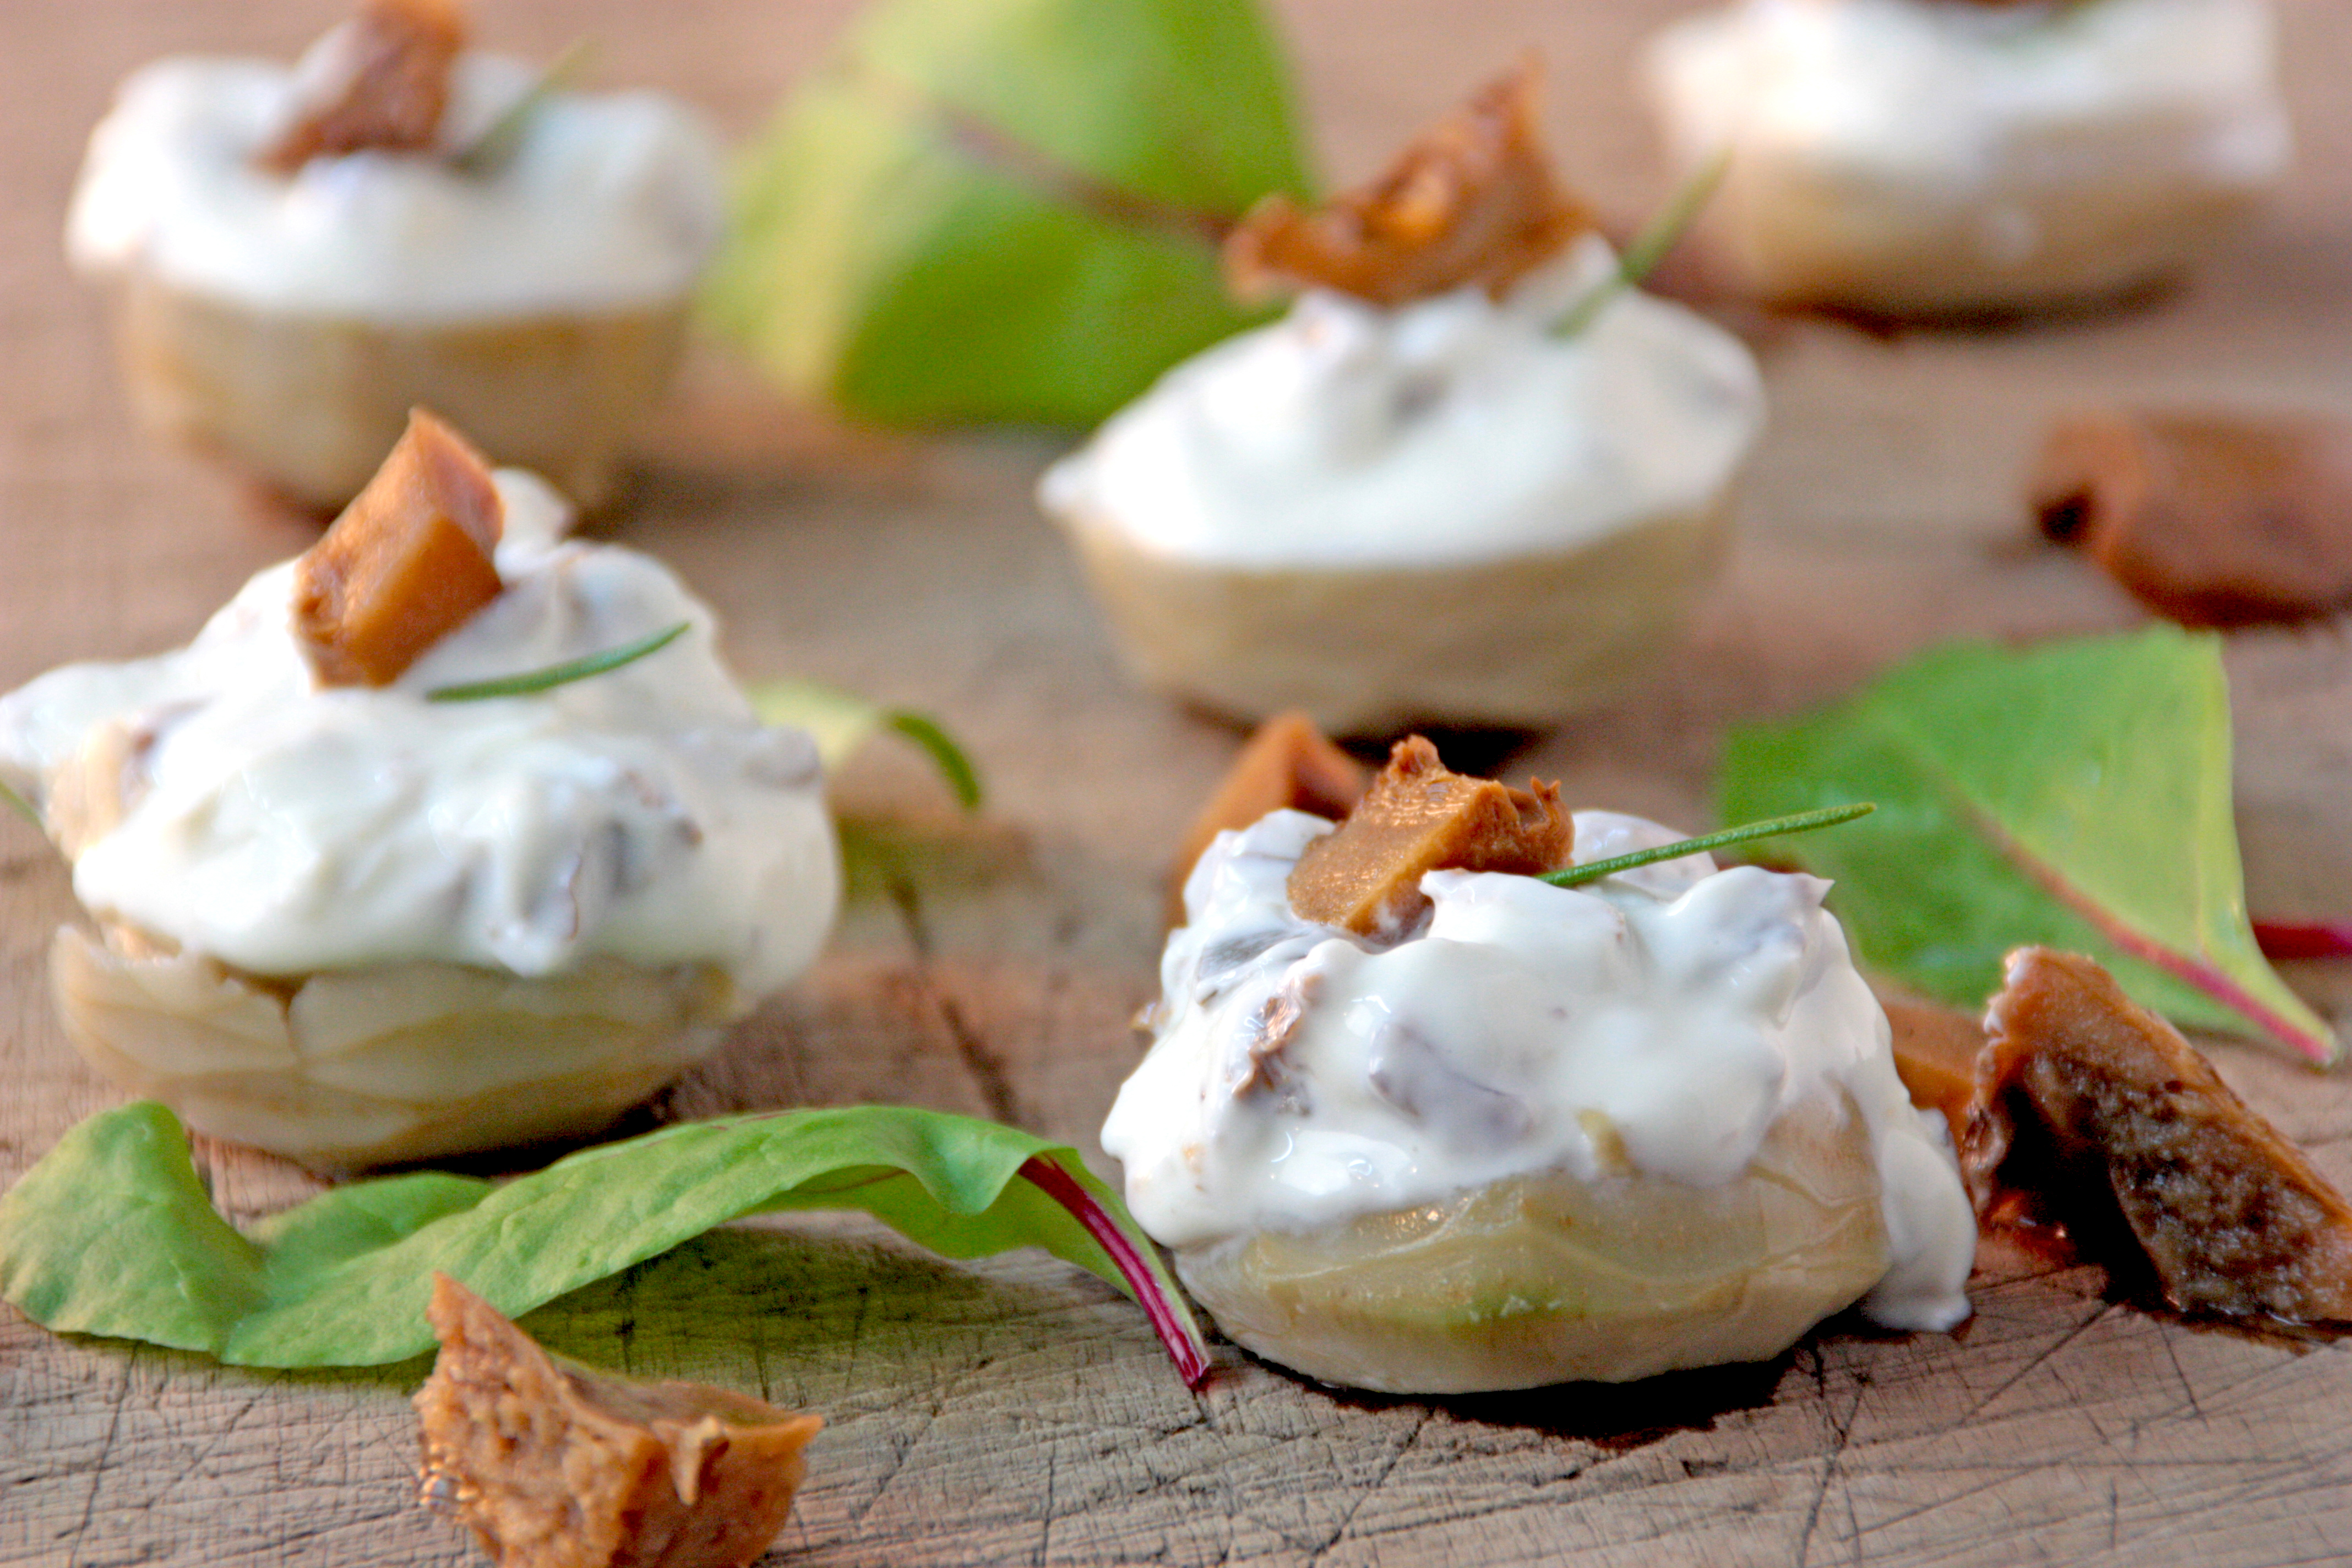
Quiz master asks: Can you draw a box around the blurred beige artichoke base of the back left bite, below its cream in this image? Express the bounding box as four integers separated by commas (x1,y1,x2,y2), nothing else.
115,275,687,510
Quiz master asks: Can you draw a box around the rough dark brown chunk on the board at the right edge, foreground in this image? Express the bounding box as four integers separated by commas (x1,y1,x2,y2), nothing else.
1962,948,2352,1324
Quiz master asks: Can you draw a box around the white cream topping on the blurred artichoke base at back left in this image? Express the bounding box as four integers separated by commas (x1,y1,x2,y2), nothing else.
66,40,727,324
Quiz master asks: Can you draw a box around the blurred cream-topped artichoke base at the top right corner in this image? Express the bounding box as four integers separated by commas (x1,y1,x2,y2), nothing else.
1649,0,2291,315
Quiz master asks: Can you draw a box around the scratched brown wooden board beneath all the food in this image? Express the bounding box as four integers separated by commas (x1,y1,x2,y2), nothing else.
14,0,2352,1568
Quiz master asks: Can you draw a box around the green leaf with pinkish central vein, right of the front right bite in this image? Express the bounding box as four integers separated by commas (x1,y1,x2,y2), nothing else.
1717,625,2338,1063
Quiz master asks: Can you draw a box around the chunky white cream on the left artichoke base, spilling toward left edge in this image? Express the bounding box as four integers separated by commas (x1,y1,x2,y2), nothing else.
0,470,840,1004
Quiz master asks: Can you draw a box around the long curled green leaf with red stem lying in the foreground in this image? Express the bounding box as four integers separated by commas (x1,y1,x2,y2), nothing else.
0,1103,1209,1385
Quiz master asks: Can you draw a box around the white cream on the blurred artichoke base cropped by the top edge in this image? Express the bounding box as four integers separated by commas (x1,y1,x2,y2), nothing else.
1649,0,2291,188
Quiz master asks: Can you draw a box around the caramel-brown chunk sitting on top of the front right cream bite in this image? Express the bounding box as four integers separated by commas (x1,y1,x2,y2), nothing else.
1289,736,1576,938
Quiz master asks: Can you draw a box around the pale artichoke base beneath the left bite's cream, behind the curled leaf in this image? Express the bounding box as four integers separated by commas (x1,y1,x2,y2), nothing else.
50,926,743,1170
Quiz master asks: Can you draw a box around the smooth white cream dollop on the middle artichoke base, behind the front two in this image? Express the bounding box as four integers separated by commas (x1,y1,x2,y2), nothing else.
1039,235,1764,567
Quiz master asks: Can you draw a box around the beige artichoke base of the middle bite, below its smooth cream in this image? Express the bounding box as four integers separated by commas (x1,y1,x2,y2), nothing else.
1061,496,1731,736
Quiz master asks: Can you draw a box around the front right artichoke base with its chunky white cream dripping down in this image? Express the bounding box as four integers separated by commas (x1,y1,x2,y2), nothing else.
1103,811,1975,1394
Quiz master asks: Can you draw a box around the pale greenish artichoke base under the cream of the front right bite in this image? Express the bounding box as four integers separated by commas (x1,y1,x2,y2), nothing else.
1176,1098,1888,1394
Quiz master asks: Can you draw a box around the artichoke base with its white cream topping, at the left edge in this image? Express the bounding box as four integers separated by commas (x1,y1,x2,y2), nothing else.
0,470,840,1168
